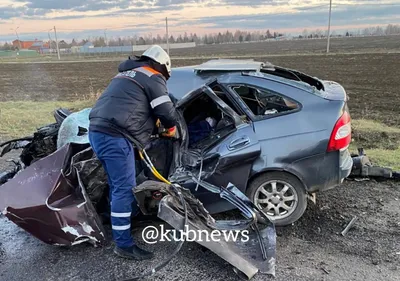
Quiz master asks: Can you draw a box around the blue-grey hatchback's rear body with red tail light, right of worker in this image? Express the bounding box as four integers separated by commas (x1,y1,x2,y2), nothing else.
167,60,353,225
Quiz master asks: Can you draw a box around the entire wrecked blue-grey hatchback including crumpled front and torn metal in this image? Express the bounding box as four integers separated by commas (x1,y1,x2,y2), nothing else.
0,57,353,278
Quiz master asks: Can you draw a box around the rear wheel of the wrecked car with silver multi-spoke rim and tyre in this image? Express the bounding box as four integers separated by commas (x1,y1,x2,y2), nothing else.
246,172,307,226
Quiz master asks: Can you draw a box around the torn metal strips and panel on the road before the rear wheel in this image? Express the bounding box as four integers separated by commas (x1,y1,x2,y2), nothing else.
134,181,276,279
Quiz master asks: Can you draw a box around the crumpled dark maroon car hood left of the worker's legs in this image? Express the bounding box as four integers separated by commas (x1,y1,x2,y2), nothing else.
0,144,106,246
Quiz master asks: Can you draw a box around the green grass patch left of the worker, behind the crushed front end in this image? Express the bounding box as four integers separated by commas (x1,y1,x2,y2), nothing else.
0,100,94,139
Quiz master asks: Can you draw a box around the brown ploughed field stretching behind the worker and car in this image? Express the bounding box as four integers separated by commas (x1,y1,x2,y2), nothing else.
0,53,400,126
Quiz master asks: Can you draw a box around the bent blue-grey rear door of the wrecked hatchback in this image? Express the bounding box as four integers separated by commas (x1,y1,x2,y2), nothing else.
179,81,261,213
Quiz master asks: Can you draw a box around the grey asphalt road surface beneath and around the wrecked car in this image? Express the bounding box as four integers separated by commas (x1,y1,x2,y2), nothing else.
0,150,400,281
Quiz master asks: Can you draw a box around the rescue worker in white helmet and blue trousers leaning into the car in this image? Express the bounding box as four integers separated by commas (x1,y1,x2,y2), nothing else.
89,45,177,260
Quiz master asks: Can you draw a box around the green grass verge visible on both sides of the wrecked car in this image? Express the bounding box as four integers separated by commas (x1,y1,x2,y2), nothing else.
0,99,400,170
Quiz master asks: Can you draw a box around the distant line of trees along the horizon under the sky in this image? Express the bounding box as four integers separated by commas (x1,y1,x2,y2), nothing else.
0,24,400,50
